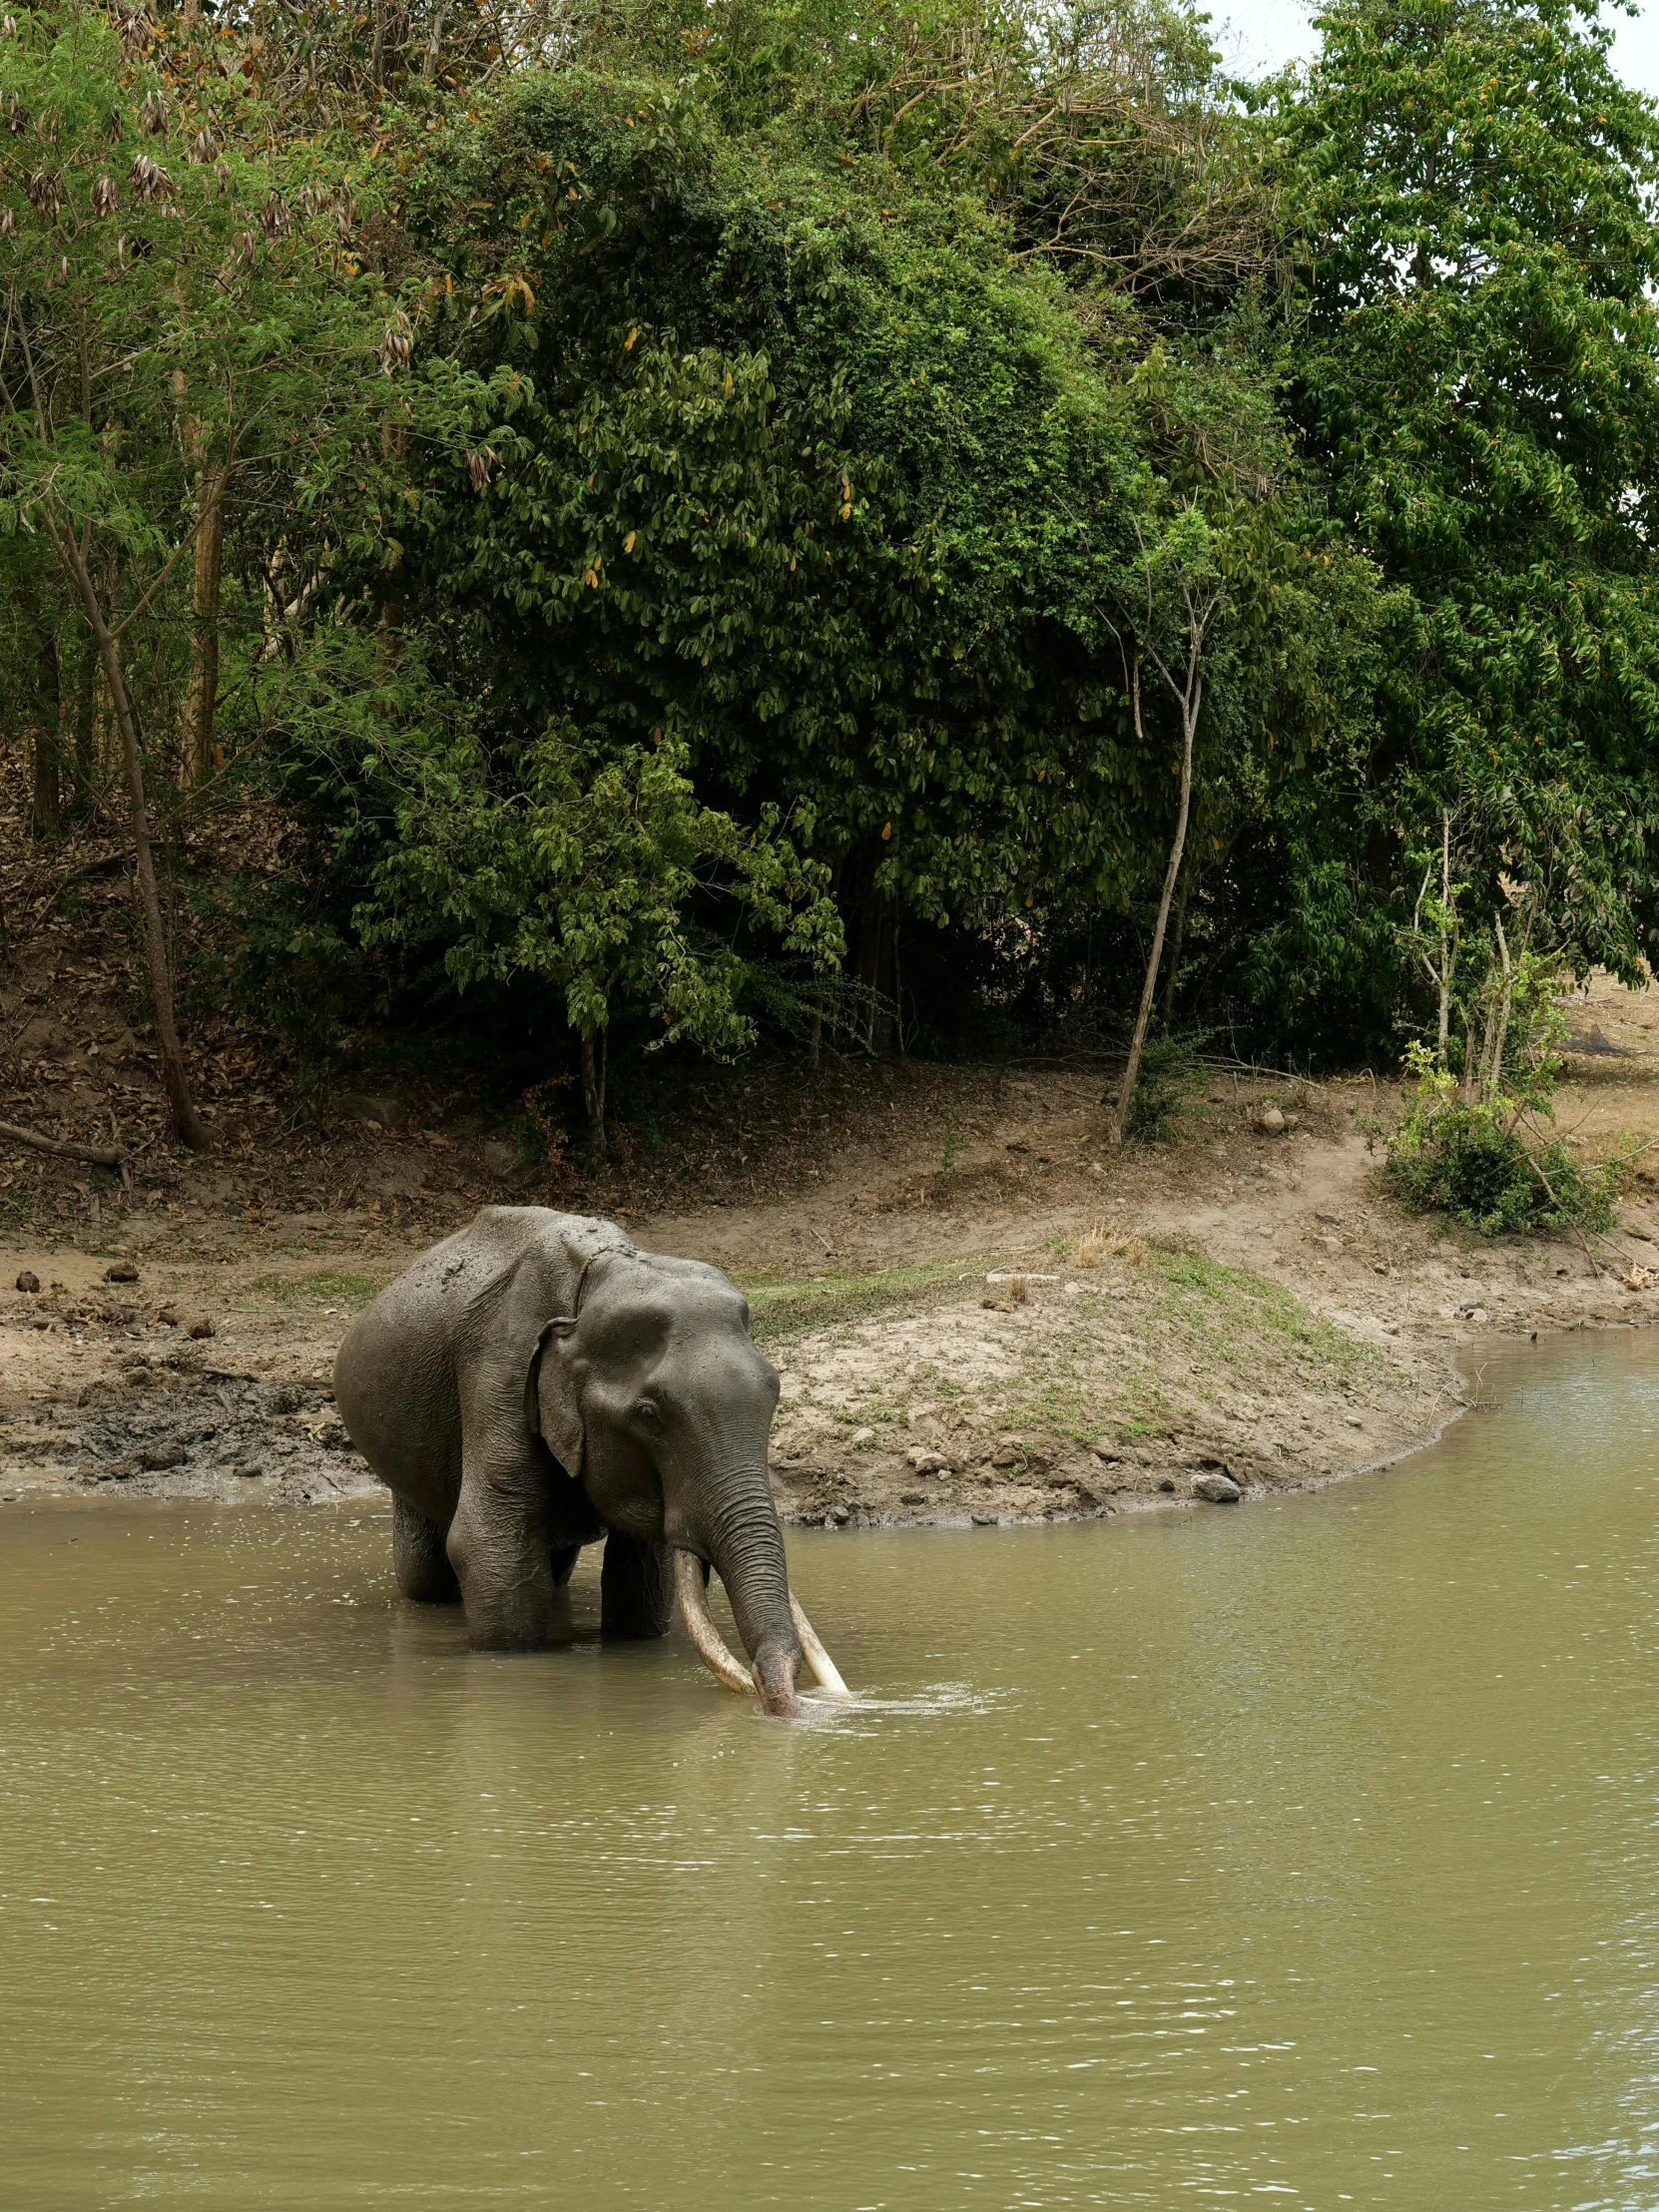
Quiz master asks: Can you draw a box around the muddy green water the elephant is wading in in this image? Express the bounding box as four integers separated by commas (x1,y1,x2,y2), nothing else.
0,1336,1659,2212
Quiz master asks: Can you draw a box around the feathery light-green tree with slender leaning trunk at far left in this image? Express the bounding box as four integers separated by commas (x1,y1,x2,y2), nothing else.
0,9,448,1146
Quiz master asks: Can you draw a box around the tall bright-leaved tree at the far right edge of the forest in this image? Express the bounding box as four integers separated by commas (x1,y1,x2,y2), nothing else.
1268,0,1659,1035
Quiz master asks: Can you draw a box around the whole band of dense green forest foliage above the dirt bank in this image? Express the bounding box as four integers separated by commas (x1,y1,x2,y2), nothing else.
0,0,1659,1141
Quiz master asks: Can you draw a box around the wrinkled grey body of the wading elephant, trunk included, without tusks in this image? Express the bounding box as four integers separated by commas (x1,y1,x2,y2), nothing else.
334,1206,801,1712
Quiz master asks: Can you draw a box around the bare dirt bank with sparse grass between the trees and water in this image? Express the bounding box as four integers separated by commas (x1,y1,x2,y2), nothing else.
0,964,1659,1526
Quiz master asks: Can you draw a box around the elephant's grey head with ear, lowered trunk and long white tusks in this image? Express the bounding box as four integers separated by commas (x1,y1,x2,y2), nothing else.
535,1250,840,1714
